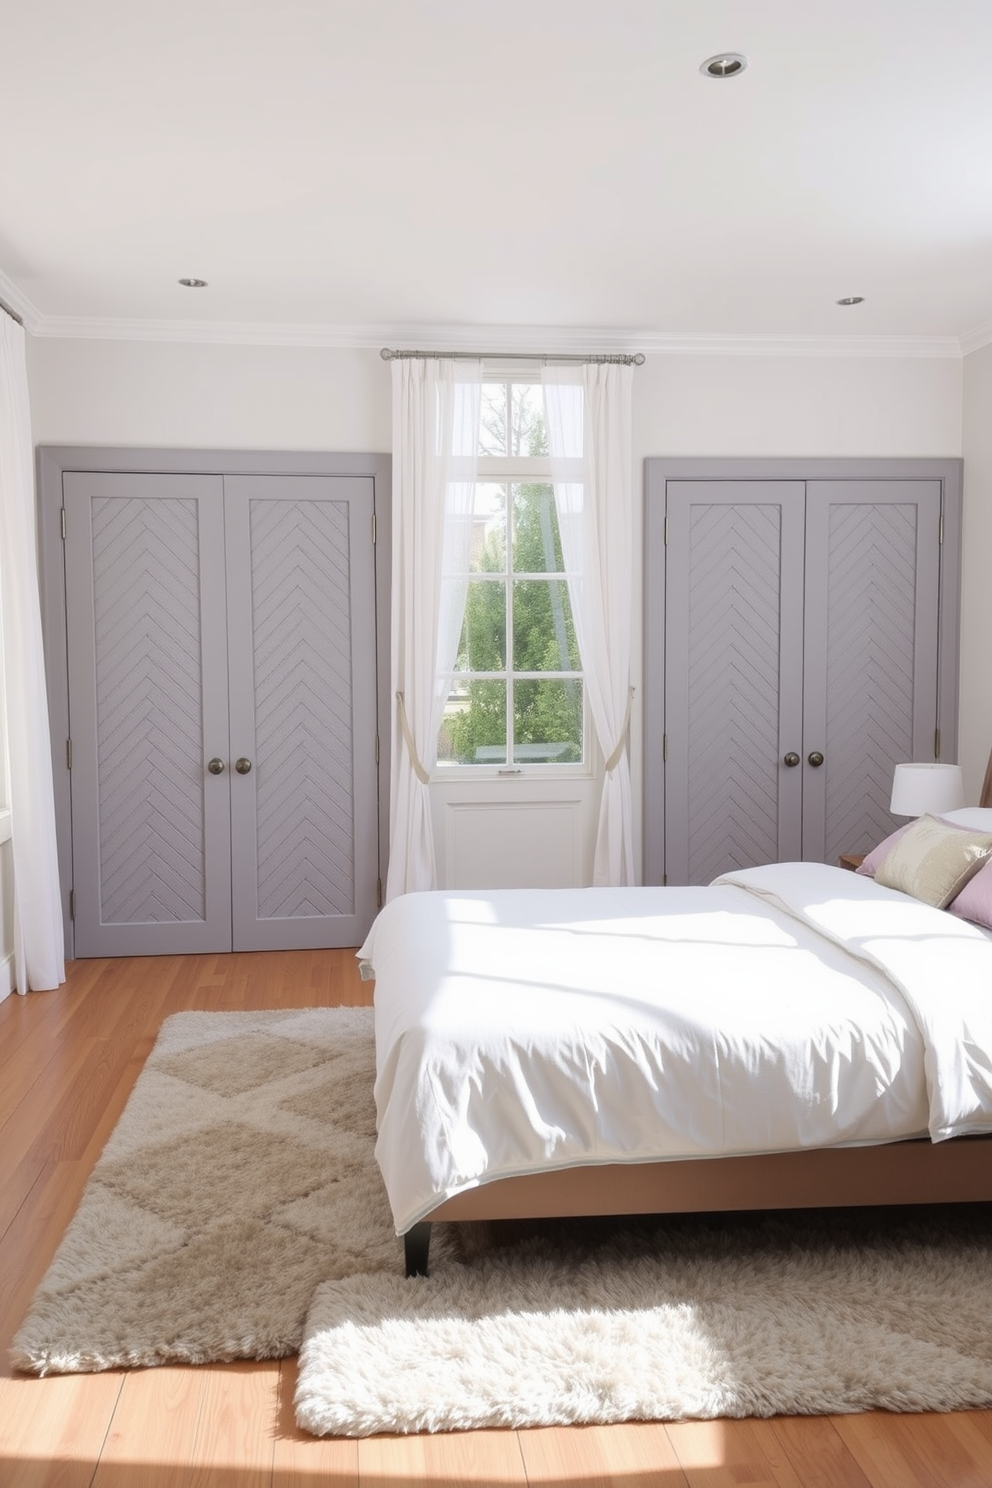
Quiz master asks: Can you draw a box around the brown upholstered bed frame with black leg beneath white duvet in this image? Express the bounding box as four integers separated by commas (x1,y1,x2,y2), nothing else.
403,754,992,1275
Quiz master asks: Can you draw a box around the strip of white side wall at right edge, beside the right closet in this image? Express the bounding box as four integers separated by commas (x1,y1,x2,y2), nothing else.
961,347,992,801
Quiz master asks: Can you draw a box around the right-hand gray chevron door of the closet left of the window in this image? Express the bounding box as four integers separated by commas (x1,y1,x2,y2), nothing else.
226,476,378,949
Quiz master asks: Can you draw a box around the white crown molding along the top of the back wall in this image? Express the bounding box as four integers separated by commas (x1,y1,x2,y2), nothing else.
11,309,963,359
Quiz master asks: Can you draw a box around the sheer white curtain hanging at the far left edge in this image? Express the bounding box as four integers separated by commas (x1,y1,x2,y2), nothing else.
0,311,65,992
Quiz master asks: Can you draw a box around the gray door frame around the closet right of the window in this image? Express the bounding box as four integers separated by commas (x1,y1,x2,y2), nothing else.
641,455,964,884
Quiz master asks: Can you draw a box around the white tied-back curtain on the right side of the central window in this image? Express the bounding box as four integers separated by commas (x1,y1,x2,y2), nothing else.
543,363,634,885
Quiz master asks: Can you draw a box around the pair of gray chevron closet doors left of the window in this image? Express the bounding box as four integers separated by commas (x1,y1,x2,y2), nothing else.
64,472,378,955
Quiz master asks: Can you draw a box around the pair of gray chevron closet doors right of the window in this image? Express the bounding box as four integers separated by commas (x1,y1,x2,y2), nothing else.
665,479,941,884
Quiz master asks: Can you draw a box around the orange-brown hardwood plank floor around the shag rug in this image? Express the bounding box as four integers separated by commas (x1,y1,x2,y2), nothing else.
0,951,992,1488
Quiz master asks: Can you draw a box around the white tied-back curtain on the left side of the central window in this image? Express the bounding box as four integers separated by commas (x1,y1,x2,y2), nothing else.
385,359,482,899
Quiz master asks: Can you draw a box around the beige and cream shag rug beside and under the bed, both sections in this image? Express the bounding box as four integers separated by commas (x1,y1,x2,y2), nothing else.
12,1007,992,1436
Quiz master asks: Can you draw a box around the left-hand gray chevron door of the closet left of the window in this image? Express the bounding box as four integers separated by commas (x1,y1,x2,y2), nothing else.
64,473,231,955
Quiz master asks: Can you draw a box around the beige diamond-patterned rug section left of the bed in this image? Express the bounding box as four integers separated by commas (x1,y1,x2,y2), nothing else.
12,1007,454,1373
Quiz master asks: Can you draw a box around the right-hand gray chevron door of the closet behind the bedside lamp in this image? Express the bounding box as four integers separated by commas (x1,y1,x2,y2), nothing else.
803,481,941,863
